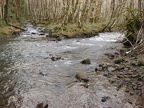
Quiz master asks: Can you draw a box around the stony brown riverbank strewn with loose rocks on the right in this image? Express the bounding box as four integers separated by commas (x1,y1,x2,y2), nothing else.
99,46,144,108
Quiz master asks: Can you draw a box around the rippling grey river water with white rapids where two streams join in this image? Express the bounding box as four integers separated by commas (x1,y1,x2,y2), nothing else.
0,25,131,108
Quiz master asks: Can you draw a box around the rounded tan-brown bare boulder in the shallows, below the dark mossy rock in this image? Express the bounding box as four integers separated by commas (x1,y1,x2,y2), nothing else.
75,72,89,82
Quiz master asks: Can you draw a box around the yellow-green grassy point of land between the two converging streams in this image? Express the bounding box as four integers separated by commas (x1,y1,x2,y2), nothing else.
46,23,106,38
